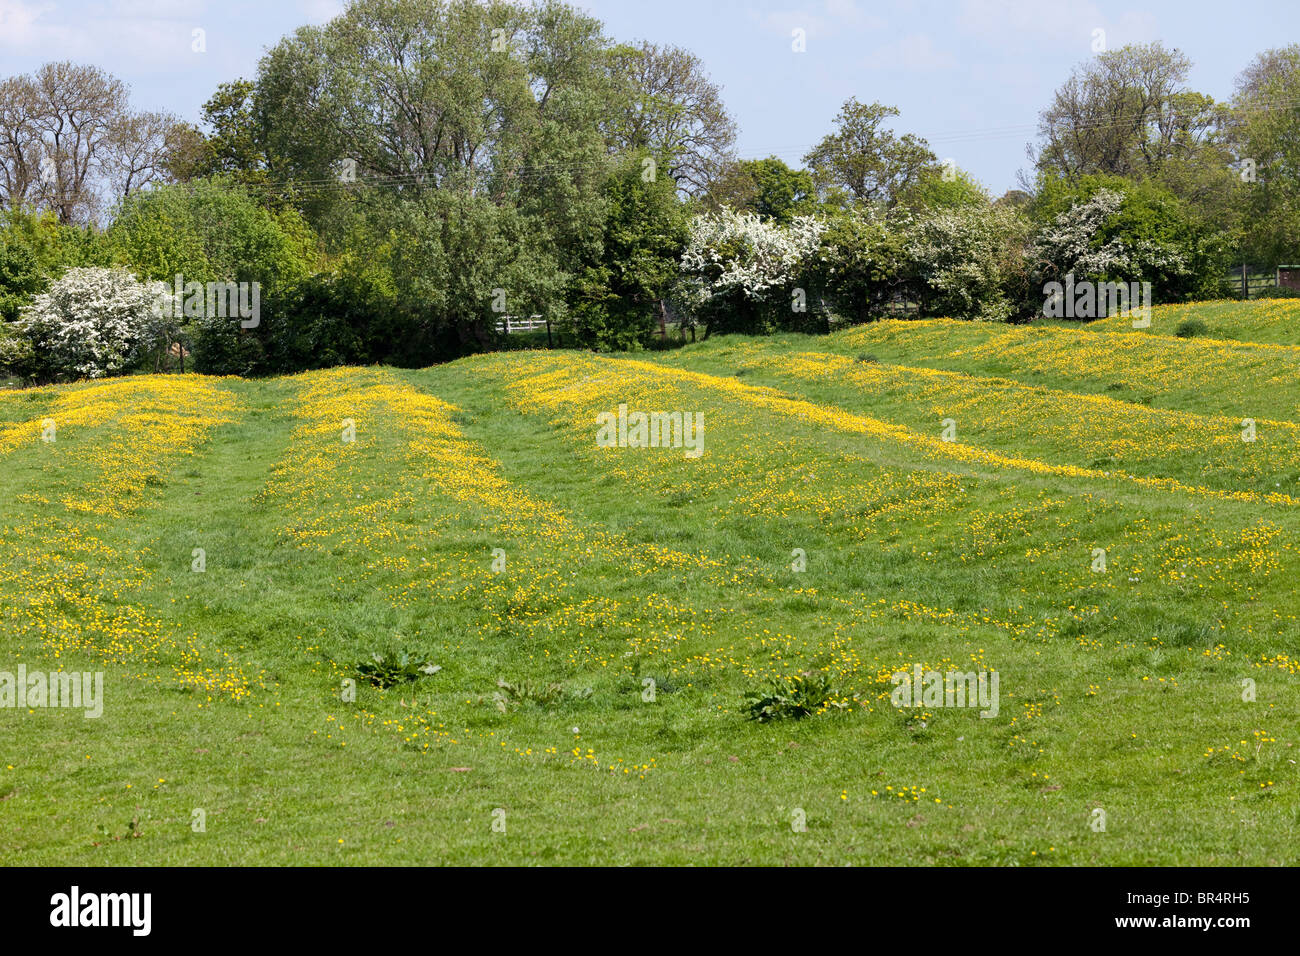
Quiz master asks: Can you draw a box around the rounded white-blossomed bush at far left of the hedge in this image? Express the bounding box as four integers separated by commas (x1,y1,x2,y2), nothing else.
17,268,168,378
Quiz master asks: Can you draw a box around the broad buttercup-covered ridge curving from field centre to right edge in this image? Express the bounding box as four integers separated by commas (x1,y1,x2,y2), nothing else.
476,345,1295,665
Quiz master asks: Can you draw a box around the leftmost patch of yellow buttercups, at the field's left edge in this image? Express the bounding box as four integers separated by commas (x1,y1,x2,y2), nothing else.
0,376,250,698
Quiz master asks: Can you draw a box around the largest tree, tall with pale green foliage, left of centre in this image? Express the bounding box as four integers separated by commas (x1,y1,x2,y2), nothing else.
254,0,612,351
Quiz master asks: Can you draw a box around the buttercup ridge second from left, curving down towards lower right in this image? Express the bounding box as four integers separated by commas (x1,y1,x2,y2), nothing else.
263,371,1076,769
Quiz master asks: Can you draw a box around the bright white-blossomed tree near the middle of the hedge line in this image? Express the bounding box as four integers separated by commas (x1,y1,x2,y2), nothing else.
681,208,826,332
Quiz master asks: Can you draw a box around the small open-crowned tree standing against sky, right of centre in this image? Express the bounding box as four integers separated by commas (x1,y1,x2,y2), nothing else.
803,98,935,207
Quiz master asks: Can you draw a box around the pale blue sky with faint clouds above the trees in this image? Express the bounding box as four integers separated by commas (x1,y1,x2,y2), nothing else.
0,0,1300,196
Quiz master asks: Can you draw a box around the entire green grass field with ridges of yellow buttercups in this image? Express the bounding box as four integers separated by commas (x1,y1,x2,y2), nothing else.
0,302,1300,865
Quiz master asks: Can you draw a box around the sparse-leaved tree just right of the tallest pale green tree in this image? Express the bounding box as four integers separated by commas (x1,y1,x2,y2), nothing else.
607,43,736,196
